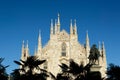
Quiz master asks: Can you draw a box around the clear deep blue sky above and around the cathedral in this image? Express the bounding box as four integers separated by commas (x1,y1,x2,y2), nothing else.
0,0,120,73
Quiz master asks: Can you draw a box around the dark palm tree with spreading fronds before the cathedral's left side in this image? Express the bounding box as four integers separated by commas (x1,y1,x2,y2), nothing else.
12,56,48,80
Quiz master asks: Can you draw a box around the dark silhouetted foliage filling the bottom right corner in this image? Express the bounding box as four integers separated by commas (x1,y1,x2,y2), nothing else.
107,64,120,80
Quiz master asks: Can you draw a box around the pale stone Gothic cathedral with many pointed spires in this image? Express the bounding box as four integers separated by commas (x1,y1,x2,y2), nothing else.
21,14,107,77
